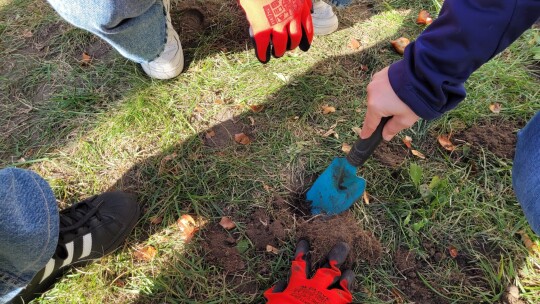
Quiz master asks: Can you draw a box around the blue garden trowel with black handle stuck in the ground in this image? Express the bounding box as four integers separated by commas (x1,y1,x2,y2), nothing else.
306,117,391,214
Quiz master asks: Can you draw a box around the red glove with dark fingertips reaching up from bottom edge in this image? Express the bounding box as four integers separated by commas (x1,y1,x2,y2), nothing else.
264,240,354,304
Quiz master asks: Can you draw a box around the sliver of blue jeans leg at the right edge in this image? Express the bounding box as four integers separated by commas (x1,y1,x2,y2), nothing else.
512,112,540,235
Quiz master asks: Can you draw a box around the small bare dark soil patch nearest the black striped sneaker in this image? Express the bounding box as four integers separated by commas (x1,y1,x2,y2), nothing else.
203,224,246,273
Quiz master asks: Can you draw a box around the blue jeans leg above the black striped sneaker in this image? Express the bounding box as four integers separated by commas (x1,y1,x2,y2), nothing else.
0,168,60,303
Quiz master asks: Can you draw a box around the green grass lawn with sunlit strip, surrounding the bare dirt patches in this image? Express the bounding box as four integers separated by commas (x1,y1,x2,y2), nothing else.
0,0,540,303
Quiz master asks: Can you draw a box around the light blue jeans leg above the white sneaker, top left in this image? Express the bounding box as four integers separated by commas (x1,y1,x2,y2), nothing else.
48,0,167,63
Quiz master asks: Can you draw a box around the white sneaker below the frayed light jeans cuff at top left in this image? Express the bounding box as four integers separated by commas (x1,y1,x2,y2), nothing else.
141,0,184,79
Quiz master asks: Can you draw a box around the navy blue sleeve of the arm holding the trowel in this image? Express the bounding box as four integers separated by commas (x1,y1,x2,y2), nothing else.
388,0,540,119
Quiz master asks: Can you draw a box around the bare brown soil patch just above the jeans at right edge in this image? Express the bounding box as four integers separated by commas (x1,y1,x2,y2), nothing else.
453,120,522,159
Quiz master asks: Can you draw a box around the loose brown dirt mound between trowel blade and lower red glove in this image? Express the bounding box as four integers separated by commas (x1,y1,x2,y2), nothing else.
297,212,382,266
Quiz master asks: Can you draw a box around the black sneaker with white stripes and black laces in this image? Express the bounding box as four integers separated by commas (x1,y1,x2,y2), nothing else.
13,192,140,303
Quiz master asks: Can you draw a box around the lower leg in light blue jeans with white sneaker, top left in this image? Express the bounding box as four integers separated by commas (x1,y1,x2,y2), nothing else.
48,0,184,79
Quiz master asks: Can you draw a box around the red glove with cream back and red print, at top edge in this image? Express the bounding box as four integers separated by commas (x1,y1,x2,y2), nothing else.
239,0,313,63
